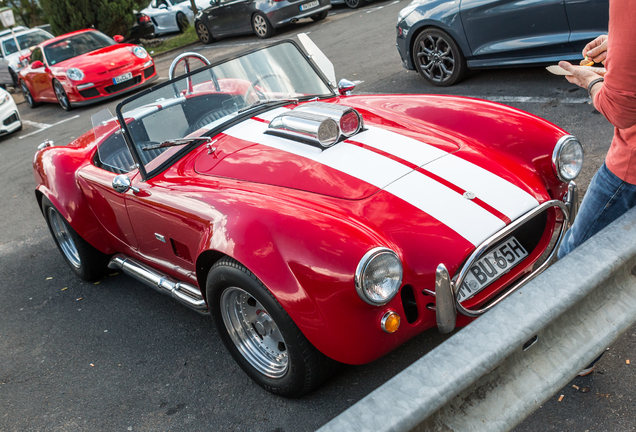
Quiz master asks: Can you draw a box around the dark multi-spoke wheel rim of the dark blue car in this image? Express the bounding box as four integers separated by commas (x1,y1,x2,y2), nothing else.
417,34,455,83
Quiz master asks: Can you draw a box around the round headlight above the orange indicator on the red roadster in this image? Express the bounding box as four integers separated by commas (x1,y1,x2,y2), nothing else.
355,248,402,306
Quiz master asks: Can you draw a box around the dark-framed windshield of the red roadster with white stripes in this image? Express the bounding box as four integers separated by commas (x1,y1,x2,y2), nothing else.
117,41,334,177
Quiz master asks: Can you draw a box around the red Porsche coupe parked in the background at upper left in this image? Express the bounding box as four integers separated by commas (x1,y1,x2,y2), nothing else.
20,29,157,111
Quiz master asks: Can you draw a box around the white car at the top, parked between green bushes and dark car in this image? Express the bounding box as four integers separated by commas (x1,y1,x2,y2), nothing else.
141,0,210,34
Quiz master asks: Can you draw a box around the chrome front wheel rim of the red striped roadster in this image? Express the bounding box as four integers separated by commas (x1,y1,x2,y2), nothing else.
220,287,289,378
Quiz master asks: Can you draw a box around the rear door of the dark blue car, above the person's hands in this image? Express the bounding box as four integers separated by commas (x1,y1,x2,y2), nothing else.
565,0,609,52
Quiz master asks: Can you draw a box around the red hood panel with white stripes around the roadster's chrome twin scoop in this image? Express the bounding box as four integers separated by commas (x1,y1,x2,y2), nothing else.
195,108,459,200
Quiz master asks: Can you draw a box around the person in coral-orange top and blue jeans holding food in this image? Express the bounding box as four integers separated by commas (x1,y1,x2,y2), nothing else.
558,0,636,376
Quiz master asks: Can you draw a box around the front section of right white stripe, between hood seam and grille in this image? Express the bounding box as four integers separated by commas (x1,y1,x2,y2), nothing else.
425,154,539,220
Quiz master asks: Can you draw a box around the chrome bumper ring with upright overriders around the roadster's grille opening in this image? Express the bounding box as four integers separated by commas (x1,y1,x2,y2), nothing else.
432,182,578,333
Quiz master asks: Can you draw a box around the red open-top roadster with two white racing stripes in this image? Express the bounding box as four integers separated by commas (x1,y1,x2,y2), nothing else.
34,41,583,397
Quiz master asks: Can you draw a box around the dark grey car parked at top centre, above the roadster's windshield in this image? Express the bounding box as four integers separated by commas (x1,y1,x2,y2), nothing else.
194,0,331,44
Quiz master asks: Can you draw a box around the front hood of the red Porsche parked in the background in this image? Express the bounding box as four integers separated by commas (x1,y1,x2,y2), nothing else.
51,44,143,74
